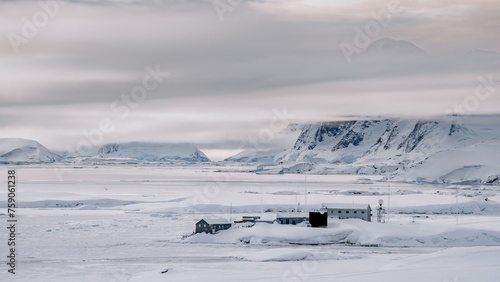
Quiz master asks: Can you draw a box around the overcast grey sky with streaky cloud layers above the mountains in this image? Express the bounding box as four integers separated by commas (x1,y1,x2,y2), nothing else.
0,0,500,159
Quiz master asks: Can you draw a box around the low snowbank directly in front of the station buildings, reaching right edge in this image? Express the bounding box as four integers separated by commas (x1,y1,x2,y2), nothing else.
186,219,500,247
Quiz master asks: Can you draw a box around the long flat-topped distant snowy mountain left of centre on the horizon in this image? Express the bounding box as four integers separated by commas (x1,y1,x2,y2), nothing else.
92,142,210,163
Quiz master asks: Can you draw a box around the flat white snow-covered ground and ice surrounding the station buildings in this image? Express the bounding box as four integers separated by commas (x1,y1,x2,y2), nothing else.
0,166,500,282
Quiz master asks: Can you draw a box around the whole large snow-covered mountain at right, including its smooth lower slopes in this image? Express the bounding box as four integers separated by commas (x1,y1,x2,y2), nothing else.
263,116,500,183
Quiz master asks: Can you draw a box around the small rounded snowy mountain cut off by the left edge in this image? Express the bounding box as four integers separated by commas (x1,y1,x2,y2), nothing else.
0,138,61,163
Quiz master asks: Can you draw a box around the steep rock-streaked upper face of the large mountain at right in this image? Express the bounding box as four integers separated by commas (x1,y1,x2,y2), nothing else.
283,119,482,164
